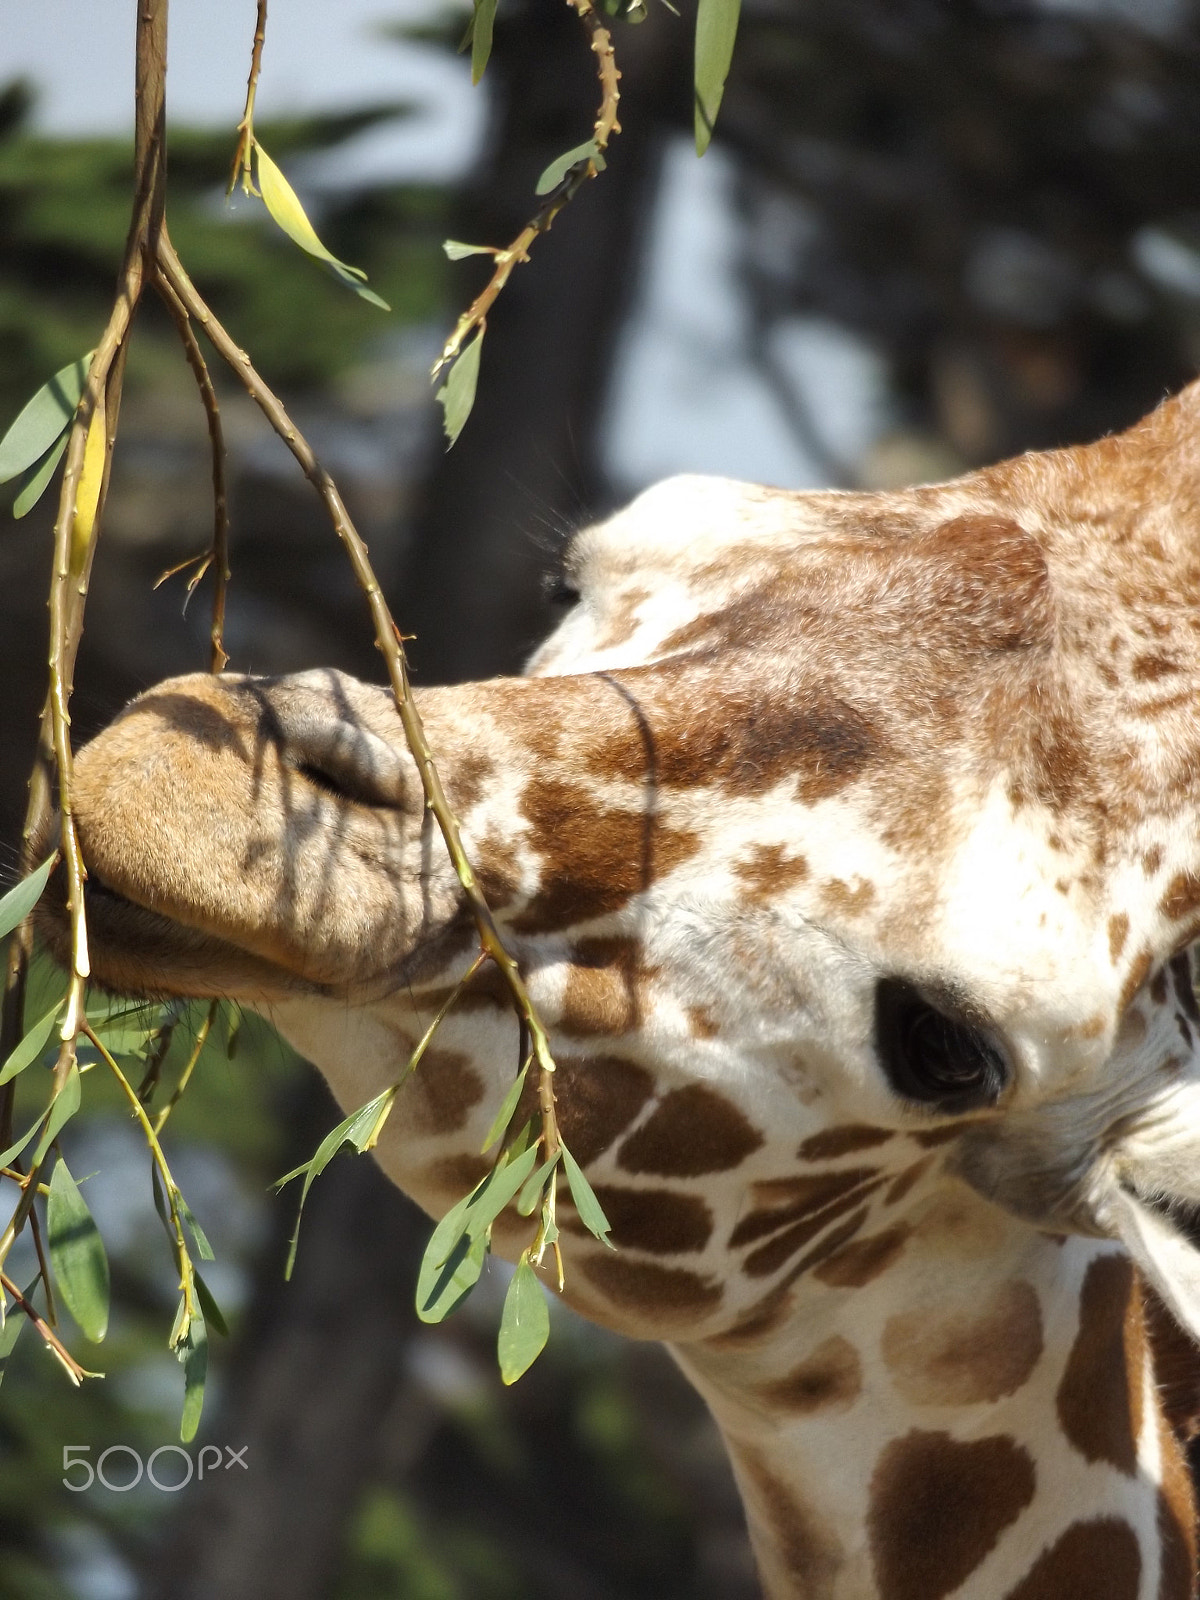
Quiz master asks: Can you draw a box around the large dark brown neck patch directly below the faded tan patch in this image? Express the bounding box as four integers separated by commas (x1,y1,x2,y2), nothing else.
867,1429,1036,1600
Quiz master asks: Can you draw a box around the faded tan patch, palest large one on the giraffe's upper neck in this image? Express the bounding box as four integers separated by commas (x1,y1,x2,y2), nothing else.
880,1278,1042,1405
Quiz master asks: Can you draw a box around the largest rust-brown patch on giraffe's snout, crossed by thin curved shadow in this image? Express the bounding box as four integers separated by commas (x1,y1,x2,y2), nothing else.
512,778,699,933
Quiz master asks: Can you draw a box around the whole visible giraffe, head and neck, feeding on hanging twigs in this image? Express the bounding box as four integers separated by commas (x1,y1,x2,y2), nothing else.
43,384,1200,1600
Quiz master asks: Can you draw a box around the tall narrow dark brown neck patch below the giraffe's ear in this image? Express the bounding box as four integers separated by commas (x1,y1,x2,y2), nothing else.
1056,1256,1146,1474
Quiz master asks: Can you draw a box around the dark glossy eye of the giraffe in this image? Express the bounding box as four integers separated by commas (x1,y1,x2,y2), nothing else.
875,978,1008,1112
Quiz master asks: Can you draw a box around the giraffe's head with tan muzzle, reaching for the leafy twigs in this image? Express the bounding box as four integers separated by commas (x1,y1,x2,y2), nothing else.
54,380,1200,1333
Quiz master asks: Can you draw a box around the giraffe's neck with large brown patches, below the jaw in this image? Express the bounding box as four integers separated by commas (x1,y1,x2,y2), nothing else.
674,1181,1195,1600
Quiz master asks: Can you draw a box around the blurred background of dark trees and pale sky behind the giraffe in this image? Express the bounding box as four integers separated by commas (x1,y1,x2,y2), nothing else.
0,0,1200,1600
